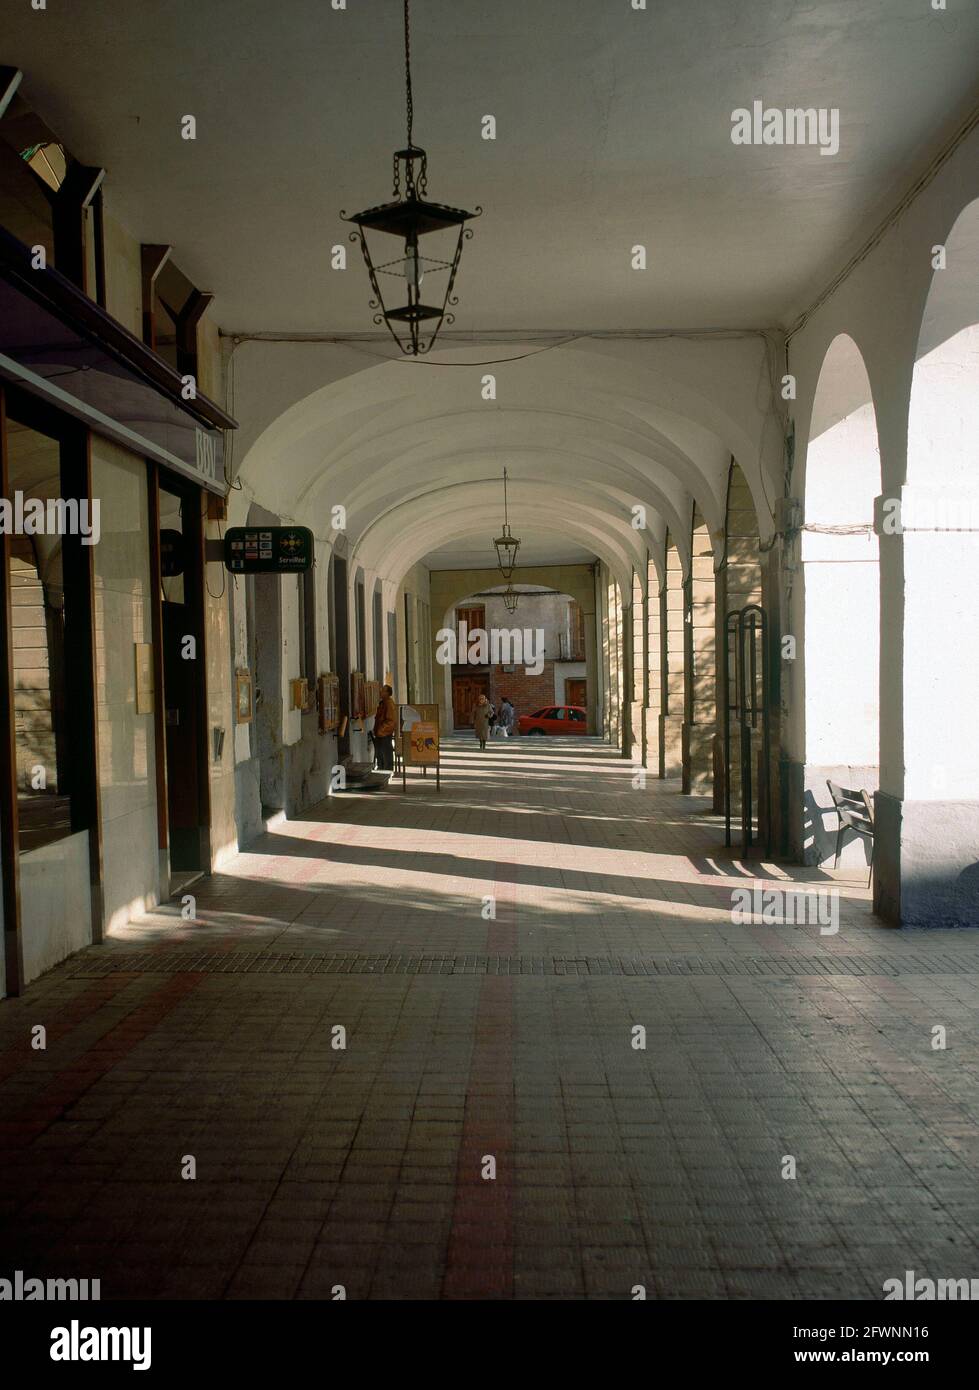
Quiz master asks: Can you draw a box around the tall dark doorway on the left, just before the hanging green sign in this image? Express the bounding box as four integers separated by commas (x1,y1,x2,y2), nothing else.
157,477,210,895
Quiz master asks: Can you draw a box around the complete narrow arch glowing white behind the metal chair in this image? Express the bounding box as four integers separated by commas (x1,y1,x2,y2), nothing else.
793,334,880,863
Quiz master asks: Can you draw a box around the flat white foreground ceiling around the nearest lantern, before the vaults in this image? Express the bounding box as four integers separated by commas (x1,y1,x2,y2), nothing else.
4,0,979,334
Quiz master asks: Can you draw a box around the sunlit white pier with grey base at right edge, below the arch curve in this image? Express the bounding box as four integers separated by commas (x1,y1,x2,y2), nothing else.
873,487,979,927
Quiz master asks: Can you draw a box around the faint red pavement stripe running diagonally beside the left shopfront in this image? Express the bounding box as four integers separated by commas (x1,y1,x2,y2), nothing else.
0,972,203,1151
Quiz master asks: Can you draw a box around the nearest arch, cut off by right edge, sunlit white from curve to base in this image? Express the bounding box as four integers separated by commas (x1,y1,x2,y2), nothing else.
877,200,979,926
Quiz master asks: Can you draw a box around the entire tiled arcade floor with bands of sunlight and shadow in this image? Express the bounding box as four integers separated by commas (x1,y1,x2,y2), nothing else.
0,739,979,1298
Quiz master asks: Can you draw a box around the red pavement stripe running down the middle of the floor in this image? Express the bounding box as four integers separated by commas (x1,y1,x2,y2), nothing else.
442,865,519,1298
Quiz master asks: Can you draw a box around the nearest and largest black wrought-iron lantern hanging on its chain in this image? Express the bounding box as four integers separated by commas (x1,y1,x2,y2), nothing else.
339,0,483,357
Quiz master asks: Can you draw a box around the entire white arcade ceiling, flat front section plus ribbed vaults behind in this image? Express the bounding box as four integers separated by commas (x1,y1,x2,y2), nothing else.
9,0,979,584
